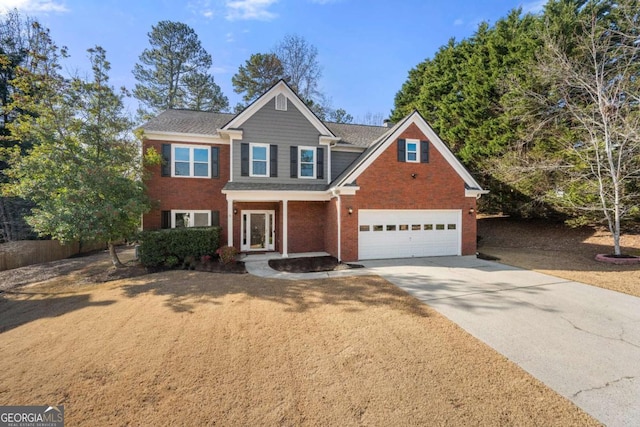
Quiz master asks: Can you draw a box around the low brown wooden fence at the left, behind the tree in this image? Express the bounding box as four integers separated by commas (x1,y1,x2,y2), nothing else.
0,240,106,271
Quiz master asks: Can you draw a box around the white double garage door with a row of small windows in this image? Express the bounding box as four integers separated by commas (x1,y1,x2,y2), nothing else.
358,209,462,259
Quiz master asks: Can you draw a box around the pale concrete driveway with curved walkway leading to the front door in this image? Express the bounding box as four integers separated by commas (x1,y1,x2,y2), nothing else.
245,257,640,426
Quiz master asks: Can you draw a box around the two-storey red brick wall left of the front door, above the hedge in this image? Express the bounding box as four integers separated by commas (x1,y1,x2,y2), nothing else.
142,140,229,237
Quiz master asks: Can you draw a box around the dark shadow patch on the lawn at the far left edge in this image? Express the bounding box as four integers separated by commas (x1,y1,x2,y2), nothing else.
0,291,115,333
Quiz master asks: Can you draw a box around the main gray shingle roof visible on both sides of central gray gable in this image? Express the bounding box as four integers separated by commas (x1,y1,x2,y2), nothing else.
141,110,389,147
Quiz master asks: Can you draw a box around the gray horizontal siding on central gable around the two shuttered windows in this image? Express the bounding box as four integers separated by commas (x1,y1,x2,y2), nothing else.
233,98,329,185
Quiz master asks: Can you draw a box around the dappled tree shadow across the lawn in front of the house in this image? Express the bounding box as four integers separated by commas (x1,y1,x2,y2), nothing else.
122,271,428,317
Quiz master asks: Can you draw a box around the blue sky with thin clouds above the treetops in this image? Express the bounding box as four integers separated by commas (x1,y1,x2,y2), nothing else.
0,0,545,121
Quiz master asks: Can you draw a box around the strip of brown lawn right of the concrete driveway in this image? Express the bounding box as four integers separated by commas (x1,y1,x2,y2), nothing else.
478,218,640,297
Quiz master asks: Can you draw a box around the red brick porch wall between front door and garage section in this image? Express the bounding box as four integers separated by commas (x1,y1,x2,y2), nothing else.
289,202,329,253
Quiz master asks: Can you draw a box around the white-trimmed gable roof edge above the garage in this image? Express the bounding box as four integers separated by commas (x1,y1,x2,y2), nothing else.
331,110,486,195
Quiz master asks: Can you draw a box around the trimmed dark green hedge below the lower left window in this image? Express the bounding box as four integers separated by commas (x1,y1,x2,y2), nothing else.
138,227,221,267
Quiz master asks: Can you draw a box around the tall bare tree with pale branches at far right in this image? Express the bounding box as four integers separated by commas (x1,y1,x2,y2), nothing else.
536,0,640,255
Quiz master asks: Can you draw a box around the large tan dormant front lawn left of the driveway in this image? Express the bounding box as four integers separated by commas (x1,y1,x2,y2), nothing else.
0,258,597,426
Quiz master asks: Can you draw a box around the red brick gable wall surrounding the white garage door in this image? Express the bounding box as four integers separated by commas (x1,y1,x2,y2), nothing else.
342,124,476,261
